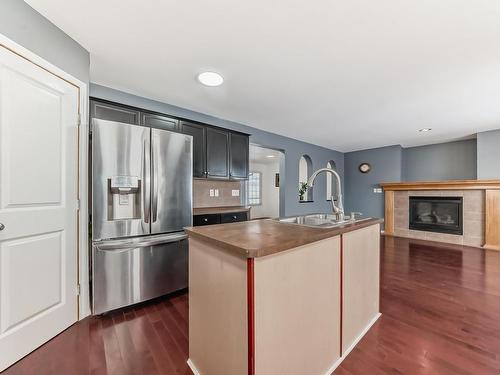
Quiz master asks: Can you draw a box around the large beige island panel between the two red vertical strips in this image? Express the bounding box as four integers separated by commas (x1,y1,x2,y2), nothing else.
254,236,340,375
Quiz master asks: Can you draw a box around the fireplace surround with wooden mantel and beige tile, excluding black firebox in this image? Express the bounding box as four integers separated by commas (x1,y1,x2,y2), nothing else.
380,180,500,250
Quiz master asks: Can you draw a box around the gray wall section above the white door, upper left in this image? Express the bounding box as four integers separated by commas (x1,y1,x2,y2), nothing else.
0,0,90,82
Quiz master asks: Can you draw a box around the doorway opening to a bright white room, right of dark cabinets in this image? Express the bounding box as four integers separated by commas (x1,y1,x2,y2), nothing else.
246,144,285,219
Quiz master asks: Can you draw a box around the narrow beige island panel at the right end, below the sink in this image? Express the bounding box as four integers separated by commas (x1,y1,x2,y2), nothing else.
342,224,380,354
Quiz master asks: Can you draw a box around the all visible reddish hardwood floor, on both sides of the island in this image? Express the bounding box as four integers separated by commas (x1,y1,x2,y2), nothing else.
4,237,500,375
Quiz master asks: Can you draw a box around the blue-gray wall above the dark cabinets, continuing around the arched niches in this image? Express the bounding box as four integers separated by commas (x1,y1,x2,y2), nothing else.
90,83,344,216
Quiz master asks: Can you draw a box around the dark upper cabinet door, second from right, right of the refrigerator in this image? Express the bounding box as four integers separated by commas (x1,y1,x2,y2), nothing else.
206,127,229,178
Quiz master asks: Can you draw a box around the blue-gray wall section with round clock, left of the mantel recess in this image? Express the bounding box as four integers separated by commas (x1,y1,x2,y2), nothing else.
344,146,403,217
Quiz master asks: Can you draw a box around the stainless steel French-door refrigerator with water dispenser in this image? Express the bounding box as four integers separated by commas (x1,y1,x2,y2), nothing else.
91,119,193,314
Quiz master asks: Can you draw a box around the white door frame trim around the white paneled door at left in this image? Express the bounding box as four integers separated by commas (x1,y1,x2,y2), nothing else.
0,34,90,320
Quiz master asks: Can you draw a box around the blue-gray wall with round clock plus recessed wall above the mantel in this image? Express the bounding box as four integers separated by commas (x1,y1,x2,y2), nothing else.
344,139,478,217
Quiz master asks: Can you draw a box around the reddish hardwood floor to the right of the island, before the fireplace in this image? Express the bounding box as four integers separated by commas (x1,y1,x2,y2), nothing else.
335,237,500,375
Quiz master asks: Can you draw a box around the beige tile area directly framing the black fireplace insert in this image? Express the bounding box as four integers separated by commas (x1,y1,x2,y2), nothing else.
394,190,485,247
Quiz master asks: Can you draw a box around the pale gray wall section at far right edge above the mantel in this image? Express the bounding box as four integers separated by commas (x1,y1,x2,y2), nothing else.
477,129,500,180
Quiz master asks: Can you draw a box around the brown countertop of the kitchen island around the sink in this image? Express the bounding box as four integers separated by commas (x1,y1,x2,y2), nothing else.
186,219,383,258
